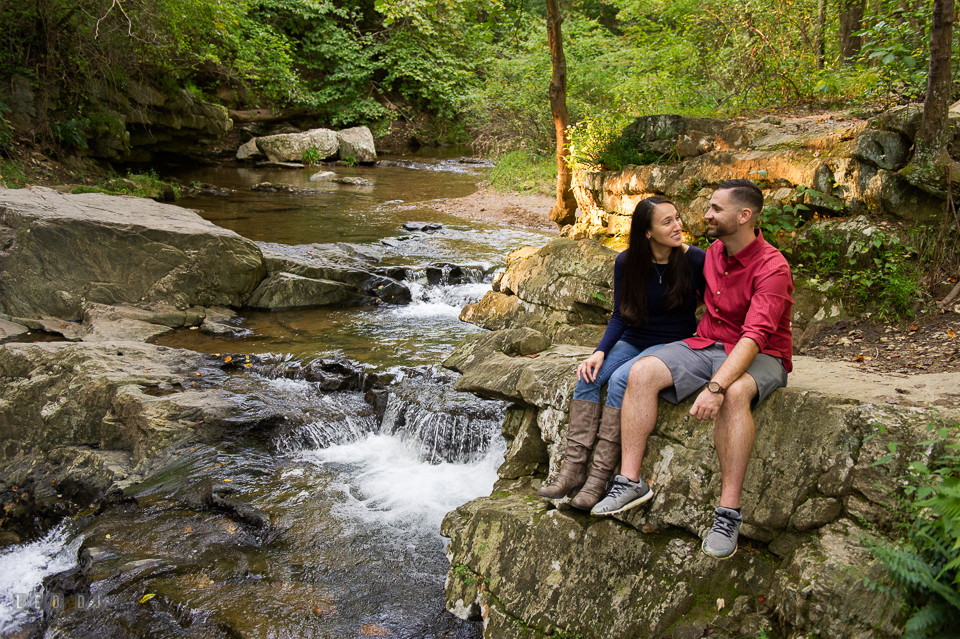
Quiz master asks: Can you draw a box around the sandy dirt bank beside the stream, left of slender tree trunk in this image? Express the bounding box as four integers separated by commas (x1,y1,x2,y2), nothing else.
430,187,559,234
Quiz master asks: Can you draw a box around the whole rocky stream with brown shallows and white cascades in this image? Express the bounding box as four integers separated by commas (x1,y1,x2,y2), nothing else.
0,158,549,639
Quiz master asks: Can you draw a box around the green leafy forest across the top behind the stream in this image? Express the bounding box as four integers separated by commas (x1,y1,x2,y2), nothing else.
0,0,960,192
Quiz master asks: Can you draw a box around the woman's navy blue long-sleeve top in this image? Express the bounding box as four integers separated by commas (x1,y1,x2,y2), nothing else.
594,246,706,354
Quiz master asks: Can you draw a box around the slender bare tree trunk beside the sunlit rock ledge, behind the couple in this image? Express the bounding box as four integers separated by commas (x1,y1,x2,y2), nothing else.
547,0,577,227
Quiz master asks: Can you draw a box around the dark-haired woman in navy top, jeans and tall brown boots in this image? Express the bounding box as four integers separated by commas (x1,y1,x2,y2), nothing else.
539,197,706,510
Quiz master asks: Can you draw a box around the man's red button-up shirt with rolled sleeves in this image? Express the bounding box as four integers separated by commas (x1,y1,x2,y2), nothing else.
684,229,793,373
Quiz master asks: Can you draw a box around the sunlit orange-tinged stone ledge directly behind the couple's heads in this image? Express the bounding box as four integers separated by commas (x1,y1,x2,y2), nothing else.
564,105,948,244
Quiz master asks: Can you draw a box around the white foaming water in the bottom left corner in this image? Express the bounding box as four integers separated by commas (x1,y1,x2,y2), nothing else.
0,524,83,634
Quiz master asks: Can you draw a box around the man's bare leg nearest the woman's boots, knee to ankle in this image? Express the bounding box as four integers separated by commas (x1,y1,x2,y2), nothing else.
620,357,673,481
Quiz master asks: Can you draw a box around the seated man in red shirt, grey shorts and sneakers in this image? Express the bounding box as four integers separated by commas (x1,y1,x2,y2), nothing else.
591,180,793,559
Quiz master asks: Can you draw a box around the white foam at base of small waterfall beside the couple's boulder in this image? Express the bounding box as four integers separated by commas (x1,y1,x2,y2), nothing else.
301,435,505,537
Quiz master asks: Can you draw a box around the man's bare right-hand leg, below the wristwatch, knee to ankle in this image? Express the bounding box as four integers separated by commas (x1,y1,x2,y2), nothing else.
712,373,757,508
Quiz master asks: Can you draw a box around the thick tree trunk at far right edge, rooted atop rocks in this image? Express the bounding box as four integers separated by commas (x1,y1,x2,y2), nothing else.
900,0,960,196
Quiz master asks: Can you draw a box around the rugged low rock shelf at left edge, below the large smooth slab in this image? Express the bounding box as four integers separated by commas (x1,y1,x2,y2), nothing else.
0,342,381,538
